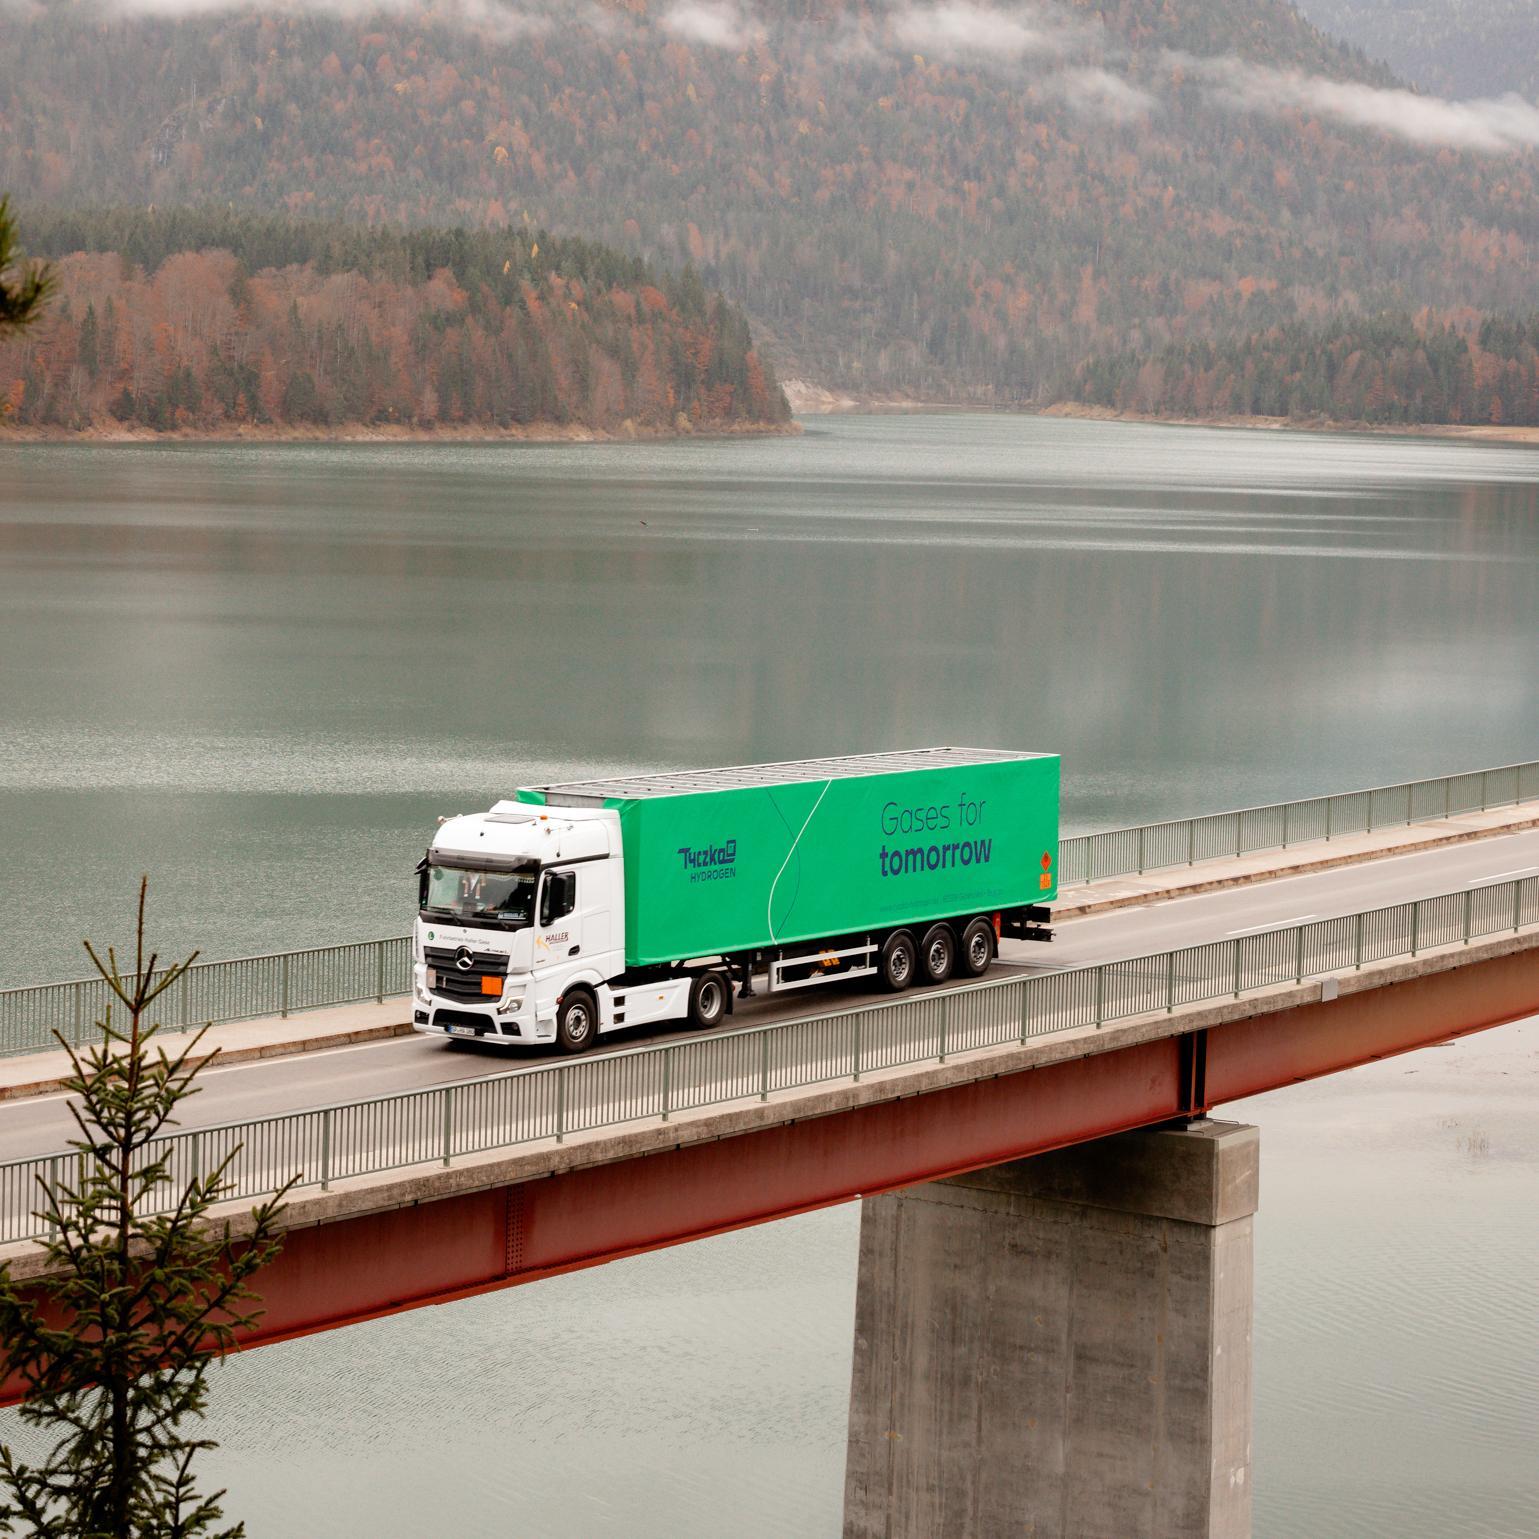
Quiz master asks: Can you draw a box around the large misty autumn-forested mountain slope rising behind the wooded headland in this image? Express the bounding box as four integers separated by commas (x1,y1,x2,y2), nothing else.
0,0,1539,402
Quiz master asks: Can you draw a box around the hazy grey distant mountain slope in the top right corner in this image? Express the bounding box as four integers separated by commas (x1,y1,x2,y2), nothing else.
1304,0,1539,102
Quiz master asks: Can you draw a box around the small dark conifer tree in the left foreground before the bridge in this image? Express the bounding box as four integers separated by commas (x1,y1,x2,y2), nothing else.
0,882,286,1539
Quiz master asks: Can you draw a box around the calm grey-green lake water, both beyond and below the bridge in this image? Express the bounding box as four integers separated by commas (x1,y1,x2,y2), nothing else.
0,417,1539,1539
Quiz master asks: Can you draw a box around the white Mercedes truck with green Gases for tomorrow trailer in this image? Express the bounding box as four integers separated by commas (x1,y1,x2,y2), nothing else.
414,748,1059,1051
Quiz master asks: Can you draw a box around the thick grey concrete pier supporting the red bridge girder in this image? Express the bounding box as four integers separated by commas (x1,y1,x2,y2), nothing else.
845,1120,1260,1539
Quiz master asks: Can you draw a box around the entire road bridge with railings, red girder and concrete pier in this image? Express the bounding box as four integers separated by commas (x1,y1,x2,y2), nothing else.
0,765,1539,1536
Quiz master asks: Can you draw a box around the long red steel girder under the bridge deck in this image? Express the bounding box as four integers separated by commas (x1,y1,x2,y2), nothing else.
0,951,1539,1402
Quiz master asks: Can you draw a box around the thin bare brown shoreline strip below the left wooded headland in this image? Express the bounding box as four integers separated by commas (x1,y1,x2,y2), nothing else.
0,419,803,445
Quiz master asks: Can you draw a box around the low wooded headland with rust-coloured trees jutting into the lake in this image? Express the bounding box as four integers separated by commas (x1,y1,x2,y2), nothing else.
0,211,788,432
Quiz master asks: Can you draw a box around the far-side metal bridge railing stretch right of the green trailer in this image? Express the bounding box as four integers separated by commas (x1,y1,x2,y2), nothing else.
1059,762,1539,886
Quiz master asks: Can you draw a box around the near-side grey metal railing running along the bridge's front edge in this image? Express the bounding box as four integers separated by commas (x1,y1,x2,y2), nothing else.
0,876,1539,1244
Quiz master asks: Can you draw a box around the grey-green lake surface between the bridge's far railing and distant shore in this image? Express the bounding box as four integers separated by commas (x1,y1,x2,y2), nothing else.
0,417,1539,982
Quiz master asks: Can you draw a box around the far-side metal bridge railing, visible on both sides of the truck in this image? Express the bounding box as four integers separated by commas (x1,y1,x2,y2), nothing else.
0,762,1539,1057
